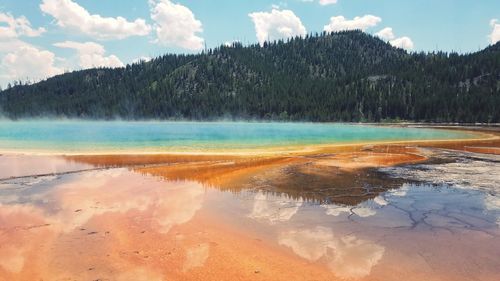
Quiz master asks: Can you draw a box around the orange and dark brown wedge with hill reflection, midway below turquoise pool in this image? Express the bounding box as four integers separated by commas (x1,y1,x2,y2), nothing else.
67,152,410,206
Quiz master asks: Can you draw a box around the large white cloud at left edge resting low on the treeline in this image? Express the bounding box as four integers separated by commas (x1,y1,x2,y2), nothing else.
0,41,63,85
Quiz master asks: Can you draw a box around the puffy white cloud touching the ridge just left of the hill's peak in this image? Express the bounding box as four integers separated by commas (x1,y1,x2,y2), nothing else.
249,9,307,45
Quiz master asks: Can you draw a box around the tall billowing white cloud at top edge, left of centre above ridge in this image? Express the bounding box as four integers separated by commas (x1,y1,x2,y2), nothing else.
150,0,205,51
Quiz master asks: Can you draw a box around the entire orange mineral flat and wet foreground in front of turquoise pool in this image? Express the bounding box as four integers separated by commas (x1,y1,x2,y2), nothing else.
0,129,500,281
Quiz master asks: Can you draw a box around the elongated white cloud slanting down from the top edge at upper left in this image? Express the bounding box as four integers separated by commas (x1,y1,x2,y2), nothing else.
40,0,151,40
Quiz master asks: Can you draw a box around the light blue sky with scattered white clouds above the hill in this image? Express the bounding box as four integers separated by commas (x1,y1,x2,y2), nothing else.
0,0,500,88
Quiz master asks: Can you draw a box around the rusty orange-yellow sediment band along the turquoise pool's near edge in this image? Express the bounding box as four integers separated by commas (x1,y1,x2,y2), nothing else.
65,127,500,195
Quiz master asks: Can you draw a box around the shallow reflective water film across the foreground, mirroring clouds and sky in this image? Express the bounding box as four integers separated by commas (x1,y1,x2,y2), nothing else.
0,156,500,281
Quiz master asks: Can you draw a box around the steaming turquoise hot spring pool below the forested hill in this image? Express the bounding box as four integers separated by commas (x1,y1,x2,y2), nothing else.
0,121,473,153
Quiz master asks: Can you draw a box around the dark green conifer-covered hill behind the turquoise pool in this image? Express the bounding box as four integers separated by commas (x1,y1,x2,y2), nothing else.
0,31,500,122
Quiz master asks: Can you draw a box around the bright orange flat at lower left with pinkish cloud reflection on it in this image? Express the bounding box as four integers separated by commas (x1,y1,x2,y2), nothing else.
0,167,352,280
